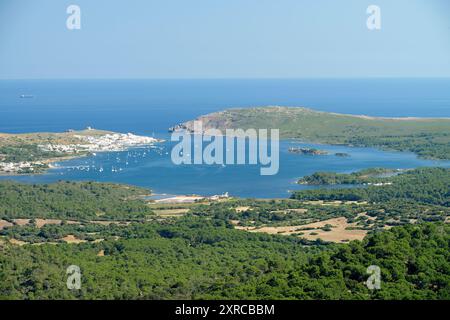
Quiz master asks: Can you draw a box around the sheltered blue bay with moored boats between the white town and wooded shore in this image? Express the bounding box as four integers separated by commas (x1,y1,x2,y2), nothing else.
0,134,450,200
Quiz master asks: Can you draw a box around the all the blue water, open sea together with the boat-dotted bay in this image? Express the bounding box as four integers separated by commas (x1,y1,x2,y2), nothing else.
0,79,450,197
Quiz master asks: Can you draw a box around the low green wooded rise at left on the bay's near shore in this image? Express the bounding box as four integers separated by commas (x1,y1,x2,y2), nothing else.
0,181,151,220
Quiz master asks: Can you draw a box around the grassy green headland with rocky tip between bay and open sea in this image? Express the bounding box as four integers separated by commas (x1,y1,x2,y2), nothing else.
181,107,450,159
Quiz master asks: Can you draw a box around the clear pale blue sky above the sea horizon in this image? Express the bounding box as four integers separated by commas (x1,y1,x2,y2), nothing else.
0,0,450,79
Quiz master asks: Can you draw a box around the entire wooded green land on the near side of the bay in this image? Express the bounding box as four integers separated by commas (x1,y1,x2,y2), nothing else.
0,168,450,300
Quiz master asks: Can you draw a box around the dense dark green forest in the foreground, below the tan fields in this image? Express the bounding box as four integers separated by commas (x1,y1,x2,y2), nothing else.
0,218,450,299
